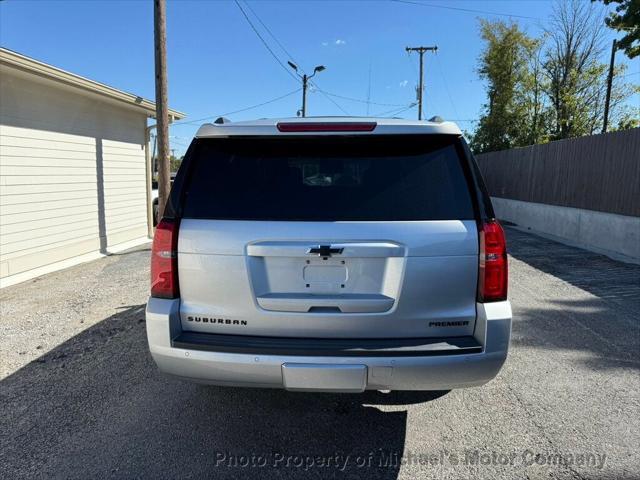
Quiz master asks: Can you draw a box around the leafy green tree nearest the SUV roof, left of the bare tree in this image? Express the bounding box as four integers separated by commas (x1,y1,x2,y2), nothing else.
471,20,539,153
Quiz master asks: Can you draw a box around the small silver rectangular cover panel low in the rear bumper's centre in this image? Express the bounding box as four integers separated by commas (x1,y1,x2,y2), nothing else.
282,363,367,393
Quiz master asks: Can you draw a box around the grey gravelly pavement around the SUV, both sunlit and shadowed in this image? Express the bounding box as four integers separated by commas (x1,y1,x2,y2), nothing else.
0,229,640,479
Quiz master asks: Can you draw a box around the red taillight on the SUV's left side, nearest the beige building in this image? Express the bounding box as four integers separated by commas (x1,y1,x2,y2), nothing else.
151,218,180,298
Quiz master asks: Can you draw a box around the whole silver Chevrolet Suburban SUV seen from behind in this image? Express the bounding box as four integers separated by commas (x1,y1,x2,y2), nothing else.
146,118,511,392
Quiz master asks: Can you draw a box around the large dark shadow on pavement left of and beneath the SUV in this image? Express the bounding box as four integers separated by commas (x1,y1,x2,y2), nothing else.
0,305,443,479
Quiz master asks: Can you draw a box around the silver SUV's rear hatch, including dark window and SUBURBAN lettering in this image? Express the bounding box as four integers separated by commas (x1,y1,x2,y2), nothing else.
174,134,478,338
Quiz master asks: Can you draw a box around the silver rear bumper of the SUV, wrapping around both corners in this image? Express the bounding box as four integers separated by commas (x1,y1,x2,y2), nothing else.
146,298,511,391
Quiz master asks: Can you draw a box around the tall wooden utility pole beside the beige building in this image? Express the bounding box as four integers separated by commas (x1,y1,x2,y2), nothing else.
153,0,171,218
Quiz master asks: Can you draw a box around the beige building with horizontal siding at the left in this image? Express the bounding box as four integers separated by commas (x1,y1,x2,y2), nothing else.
0,49,184,286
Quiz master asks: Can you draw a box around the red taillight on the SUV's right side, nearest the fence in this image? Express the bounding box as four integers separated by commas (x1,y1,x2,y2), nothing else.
478,220,508,302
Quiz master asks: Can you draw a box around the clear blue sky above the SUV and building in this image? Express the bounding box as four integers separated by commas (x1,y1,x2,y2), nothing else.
0,0,640,154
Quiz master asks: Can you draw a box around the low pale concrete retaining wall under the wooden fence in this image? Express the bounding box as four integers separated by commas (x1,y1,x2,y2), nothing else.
491,197,640,261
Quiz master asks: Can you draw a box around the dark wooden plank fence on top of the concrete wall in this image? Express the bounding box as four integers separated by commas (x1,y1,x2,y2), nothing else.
476,128,640,217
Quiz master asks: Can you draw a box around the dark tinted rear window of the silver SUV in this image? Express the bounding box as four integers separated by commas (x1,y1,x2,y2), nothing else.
183,135,474,221
